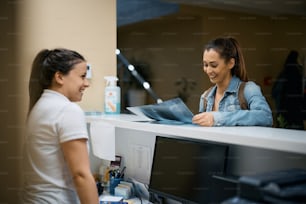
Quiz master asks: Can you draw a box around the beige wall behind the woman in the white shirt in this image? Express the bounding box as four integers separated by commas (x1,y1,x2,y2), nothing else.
18,0,116,111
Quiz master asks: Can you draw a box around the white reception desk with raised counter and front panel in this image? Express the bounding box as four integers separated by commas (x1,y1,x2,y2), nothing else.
87,114,306,186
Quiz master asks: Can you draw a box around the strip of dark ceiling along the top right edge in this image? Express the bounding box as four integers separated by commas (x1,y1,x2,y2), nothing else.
117,0,306,27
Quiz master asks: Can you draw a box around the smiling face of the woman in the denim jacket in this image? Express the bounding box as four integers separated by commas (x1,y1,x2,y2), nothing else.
203,49,235,84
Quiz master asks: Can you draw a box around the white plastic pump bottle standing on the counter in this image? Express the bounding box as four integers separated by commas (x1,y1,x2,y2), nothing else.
104,76,121,114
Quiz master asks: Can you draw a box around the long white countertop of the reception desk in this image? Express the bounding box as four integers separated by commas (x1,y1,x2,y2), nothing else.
86,114,306,154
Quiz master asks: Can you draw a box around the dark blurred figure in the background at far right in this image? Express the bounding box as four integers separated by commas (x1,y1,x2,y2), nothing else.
272,50,304,130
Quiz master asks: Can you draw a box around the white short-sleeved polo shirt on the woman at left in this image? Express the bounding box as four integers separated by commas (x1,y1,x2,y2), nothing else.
23,90,88,204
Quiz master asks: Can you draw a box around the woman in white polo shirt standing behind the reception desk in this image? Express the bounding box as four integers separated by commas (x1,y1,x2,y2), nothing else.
22,49,98,204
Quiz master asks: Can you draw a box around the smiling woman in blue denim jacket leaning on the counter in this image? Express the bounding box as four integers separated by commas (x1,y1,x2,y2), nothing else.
193,37,273,126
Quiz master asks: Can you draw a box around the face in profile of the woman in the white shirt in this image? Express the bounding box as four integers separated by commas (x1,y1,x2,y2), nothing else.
61,62,89,102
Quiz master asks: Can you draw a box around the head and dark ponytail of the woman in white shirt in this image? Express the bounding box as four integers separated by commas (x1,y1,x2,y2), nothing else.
29,49,89,112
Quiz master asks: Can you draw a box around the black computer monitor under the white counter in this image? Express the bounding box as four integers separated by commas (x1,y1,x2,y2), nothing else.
149,136,228,204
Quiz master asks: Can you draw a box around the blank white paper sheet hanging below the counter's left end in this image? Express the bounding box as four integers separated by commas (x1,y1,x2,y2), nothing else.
90,121,115,161
